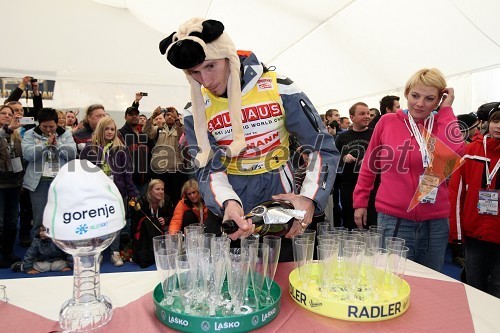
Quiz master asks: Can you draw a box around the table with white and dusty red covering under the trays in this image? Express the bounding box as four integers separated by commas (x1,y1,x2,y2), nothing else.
0,261,500,333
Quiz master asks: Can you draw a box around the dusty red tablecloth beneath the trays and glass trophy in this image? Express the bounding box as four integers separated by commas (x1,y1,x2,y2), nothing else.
0,263,474,333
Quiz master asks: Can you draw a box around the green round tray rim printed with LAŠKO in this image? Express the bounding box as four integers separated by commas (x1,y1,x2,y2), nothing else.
153,281,281,333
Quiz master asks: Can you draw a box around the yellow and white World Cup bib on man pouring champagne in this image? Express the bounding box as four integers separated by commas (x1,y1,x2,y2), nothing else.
202,72,290,175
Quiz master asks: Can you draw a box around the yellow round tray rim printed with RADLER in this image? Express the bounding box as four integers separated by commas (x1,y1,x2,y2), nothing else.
289,263,410,322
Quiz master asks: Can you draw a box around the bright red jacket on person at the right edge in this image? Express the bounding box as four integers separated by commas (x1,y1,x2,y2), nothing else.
449,135,500,244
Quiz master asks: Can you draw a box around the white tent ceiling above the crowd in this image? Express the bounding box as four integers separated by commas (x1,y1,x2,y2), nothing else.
0,0,500,114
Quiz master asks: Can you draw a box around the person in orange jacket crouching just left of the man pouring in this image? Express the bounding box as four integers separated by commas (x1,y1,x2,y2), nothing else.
168,179,208,234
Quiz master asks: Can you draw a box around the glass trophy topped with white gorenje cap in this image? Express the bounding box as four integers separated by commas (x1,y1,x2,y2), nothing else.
43,160,125,332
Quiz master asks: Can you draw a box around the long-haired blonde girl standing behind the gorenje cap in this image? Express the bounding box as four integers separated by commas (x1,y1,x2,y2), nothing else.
80,117,139,266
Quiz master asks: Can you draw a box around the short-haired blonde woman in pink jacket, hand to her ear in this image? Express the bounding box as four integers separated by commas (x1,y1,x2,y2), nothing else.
353,69,464,271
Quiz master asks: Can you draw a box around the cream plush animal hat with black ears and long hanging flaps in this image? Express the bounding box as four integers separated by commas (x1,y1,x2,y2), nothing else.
160,18,246,167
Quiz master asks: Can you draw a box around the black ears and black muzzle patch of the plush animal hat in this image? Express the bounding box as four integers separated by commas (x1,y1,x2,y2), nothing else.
160,20,224,69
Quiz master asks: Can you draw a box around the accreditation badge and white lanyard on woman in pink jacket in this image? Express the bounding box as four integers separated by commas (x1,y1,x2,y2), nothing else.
408,112,441,204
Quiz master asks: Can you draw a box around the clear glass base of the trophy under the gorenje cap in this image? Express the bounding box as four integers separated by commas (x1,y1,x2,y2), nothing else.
59,295,113,332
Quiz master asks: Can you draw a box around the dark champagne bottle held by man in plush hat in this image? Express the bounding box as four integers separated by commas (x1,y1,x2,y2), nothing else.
221,200,305,236
